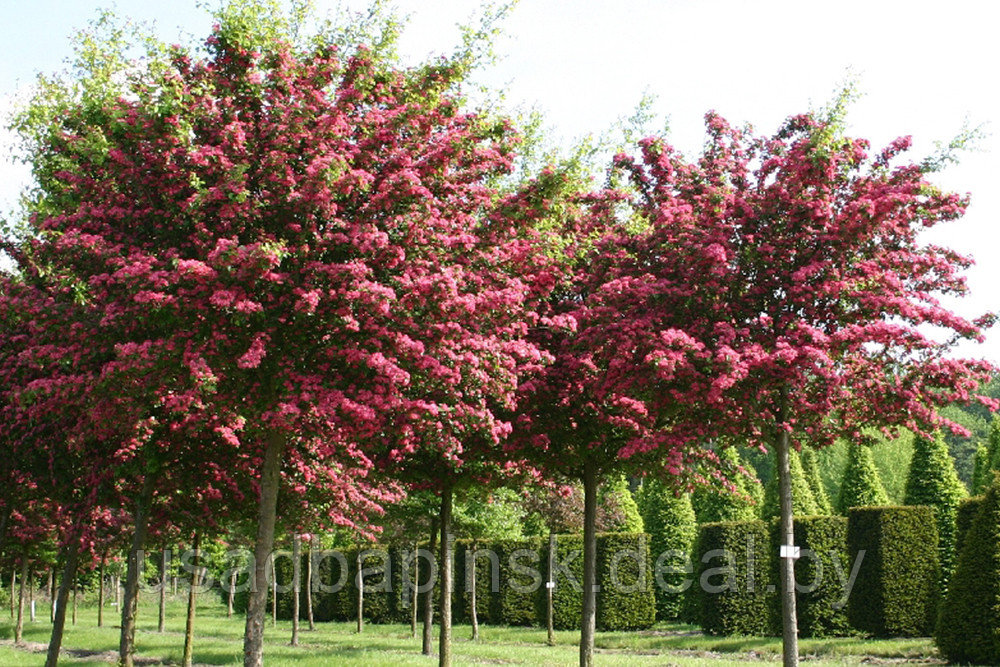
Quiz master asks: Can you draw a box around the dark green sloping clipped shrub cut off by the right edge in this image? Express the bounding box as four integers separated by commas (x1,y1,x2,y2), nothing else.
935,479,1000,665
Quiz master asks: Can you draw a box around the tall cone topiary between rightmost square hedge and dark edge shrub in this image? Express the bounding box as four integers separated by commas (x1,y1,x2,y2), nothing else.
903,433,967,591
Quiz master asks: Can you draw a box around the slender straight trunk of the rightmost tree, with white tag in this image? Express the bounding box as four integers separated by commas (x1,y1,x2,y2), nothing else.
776,389,799,667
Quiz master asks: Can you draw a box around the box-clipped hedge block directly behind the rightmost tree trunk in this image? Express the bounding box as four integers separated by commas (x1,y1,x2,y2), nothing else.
769,516,854,637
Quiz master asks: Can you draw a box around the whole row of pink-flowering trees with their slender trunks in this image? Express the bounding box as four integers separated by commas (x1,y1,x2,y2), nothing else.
0,0,995,665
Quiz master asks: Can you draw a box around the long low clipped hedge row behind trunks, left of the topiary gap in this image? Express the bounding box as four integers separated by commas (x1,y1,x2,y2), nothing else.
235,533,656,630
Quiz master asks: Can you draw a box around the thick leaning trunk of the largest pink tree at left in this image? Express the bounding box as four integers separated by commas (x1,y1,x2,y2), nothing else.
243,433,285,667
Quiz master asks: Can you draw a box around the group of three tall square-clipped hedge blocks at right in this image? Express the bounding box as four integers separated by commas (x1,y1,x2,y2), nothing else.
692,507,939,637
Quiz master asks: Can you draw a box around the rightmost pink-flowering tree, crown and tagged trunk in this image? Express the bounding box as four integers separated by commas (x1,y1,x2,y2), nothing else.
606,104,995,664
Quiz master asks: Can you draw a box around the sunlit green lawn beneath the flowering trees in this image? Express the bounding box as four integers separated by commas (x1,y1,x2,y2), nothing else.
0,595,939,667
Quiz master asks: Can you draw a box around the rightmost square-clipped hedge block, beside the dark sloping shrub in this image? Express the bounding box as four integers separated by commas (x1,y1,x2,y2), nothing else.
847,506,940,637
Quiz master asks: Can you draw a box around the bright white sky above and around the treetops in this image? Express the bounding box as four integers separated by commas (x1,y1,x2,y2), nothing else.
0,0,1000,363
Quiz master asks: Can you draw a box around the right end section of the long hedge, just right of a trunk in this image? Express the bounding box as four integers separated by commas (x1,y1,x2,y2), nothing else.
592,533,656,630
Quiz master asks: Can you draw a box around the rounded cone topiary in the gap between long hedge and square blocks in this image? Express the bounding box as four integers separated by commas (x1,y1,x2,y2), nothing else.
638,477,698,621
